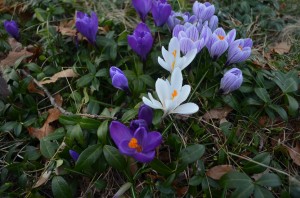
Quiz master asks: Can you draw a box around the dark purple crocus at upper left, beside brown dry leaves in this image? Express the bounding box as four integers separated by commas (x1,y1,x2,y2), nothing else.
75,11,98,44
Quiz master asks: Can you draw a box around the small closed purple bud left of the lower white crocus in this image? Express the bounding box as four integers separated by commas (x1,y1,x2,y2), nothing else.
109,66,129,92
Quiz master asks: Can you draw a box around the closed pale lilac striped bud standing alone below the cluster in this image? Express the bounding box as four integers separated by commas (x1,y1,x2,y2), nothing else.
220,68,243,94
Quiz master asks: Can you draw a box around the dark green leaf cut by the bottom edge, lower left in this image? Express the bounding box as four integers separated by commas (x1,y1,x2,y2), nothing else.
51,176,73,198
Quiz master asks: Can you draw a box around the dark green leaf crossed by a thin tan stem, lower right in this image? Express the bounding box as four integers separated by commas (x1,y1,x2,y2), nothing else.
243,152,271,173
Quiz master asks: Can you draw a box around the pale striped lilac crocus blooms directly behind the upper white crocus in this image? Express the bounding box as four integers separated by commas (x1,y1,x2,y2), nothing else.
173,23,212,54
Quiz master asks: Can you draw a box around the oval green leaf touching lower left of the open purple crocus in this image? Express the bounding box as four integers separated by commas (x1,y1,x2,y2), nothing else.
103,145,127,171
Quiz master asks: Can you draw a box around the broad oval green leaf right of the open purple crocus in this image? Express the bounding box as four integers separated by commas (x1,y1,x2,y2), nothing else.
179,144,205,164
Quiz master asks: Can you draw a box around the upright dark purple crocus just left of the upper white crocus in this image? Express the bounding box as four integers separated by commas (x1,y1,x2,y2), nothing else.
127,23,153,60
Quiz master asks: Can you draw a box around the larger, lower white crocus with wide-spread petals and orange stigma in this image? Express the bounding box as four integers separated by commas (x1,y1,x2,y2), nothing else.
143,67,199,117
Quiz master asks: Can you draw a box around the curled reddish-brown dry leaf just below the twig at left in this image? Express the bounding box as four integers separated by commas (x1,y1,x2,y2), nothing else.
28,108,61,140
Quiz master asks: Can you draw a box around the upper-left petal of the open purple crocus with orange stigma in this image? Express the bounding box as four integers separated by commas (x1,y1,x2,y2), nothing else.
109,121,133,147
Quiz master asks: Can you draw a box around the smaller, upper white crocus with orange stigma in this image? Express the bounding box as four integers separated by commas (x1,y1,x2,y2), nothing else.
158,37,197,73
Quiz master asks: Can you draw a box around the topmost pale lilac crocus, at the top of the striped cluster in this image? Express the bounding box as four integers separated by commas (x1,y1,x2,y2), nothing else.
193,1,215,21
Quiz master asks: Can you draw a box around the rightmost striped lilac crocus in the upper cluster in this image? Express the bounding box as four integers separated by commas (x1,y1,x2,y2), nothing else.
225,38,253,66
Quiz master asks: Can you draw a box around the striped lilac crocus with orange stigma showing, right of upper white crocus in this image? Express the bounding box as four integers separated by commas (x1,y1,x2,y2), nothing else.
206,28,236,60
